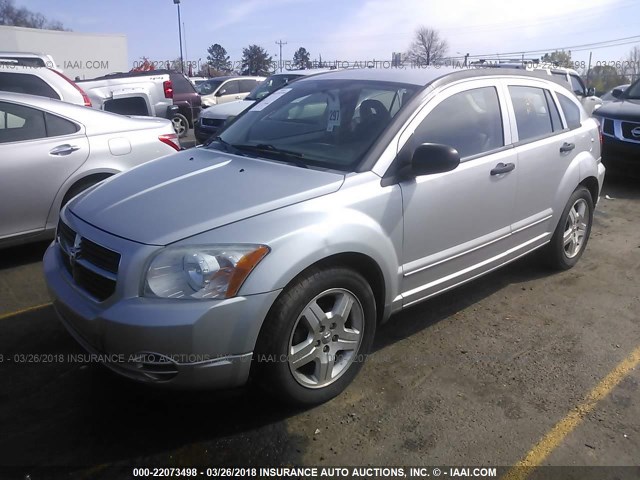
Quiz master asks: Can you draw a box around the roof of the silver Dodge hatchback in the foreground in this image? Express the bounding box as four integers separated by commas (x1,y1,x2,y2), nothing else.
296,66,558,86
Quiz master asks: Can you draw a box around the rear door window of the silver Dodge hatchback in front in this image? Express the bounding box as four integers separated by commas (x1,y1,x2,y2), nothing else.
509,85,553,142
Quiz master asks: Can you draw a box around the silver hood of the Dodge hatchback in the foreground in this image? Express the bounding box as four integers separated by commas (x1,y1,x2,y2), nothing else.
69,148,344,245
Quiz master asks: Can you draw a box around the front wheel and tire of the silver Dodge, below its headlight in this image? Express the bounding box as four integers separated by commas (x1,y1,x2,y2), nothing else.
254,267,376,406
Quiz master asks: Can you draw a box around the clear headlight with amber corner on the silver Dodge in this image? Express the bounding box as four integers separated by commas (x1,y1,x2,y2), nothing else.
144,245,269,300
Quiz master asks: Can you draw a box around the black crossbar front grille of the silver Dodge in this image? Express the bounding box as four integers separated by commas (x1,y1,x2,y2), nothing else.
57,220,120,302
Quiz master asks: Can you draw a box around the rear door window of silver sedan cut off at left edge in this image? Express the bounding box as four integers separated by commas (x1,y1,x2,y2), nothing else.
0,98,47,143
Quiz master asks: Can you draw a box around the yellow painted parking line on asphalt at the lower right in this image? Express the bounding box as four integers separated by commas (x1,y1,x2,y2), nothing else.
503,347,640,480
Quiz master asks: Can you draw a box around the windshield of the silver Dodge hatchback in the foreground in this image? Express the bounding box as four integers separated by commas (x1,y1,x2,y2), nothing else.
207,80,420,171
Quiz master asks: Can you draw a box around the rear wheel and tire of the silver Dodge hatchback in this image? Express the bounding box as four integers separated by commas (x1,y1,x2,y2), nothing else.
547,186,593,270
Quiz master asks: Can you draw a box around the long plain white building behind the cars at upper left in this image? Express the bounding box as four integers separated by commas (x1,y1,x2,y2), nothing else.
0,25,126,80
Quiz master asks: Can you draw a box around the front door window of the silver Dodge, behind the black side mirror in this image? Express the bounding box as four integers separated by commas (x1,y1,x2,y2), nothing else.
414,87,504,158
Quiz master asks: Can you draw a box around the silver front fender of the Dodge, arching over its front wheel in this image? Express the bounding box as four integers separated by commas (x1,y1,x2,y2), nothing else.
189,172,403,316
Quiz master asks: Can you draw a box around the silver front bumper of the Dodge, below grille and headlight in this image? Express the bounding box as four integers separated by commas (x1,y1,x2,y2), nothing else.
44,243,280,388
